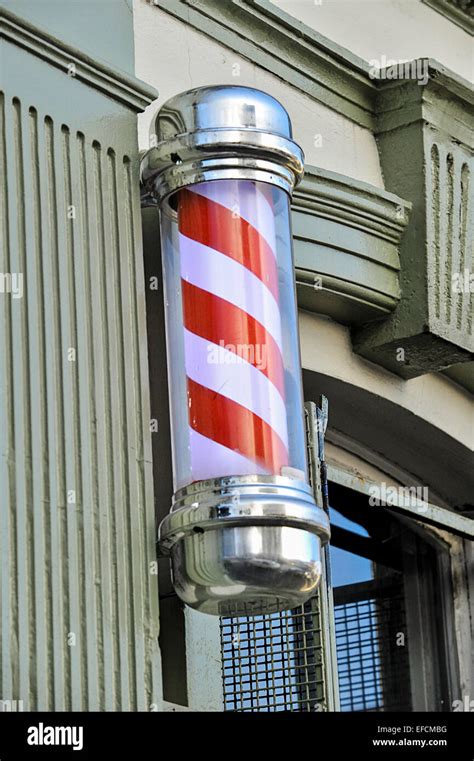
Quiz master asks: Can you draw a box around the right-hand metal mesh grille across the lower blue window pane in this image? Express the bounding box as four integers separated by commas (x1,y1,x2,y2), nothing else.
334,580,411,711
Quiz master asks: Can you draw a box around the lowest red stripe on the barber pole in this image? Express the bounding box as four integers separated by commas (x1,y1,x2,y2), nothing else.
188,378,288,475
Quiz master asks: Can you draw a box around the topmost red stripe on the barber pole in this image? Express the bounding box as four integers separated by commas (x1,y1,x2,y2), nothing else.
178,190,278,302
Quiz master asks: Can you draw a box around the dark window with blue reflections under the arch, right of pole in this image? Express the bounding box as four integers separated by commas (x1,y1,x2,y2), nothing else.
330,484,450,711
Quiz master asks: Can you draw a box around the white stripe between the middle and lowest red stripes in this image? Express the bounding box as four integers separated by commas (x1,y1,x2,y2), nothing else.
184,328,288,448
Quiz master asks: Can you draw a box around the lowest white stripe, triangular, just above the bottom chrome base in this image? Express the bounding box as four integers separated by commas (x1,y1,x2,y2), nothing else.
189,427,270,481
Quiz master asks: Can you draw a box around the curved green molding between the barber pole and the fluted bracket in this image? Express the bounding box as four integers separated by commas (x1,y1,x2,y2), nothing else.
292,166,411,325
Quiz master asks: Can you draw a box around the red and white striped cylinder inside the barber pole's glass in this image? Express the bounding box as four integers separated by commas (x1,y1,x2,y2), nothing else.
178,180,288,481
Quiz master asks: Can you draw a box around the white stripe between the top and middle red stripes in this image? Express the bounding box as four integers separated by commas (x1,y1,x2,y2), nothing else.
179,233,282,350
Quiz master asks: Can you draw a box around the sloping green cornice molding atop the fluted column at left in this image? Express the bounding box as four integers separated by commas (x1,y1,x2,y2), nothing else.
0,8,158,112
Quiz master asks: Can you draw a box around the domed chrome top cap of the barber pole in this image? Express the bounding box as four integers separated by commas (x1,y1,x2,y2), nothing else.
141,85,304,203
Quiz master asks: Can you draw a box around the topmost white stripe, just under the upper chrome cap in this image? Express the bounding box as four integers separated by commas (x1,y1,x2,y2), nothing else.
192,180,276,256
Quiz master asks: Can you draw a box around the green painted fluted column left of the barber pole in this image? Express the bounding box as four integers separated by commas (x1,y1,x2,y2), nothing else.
0,0,161,711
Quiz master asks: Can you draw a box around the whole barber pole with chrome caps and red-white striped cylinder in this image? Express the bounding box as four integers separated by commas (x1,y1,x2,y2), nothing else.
141,86,329,616
